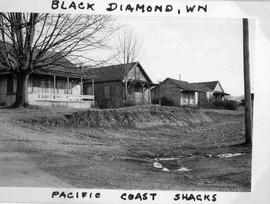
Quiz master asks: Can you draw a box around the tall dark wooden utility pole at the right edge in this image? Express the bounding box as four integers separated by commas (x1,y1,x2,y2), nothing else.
243,18,252,144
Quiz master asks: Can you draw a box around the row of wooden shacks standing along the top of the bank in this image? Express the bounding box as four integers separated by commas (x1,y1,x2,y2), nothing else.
0,59,228,108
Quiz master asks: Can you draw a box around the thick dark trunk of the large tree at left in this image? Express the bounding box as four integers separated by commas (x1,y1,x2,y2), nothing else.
11,74,29,108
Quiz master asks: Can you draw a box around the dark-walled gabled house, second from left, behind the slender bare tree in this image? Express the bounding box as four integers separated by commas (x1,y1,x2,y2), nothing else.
84,62,155,107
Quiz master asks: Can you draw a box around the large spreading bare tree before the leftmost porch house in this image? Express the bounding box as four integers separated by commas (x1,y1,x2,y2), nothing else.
0,13,113,107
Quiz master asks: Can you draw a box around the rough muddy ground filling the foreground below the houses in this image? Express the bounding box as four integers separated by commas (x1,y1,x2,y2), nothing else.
0,108,251,191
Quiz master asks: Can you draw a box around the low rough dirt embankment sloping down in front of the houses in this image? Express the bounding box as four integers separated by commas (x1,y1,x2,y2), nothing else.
19,106,244,128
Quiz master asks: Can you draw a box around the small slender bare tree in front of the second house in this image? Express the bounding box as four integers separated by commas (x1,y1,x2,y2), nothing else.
115,28,142,101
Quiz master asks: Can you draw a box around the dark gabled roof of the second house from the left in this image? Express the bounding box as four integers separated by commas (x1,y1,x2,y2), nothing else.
86,62,152,83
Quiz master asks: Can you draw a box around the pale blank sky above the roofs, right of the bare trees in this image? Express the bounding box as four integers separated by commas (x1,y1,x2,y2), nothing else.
106,16,254,96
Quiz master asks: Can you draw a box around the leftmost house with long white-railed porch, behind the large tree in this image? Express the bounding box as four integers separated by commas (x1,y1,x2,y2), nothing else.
0,58,94,108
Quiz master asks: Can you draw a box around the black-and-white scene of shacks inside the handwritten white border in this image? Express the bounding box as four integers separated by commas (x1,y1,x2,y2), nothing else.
0,0,270,201
